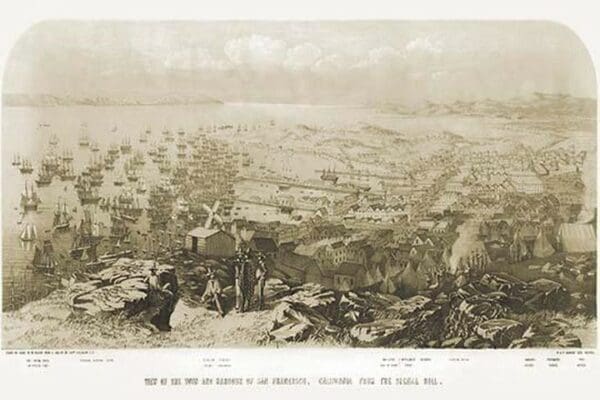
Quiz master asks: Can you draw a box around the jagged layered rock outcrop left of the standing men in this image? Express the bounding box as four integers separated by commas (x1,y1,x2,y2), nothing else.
68,258,178,331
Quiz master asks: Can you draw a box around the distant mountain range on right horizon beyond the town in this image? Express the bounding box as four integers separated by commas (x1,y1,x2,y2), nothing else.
382,93,596,119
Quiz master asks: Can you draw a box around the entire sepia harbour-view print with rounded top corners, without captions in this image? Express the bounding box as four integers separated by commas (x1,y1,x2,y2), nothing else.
2,21,597,349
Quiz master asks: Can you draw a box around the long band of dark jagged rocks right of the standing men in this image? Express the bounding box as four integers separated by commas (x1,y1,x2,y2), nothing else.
266,274,581,349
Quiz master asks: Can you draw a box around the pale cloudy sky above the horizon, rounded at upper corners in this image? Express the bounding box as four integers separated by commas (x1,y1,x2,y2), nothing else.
2,21,596,105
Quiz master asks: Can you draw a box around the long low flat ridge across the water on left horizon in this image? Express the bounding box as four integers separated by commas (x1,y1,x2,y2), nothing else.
2,93,222,107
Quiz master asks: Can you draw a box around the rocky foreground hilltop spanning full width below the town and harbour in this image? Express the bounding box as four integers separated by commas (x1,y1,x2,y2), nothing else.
2,260,596,349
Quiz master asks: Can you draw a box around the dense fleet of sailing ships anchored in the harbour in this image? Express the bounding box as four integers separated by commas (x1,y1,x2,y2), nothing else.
7,124,239,288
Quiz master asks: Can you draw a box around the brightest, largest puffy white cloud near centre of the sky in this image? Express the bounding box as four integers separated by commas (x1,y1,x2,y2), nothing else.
224,34,287,66
